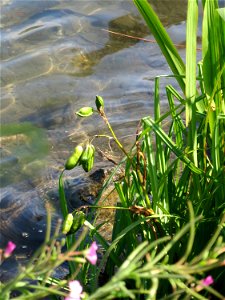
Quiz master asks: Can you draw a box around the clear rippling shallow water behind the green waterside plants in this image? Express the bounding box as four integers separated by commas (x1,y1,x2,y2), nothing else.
0,0,190,280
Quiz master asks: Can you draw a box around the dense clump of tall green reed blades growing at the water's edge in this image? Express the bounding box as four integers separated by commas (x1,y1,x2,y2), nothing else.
92,0,225,296
